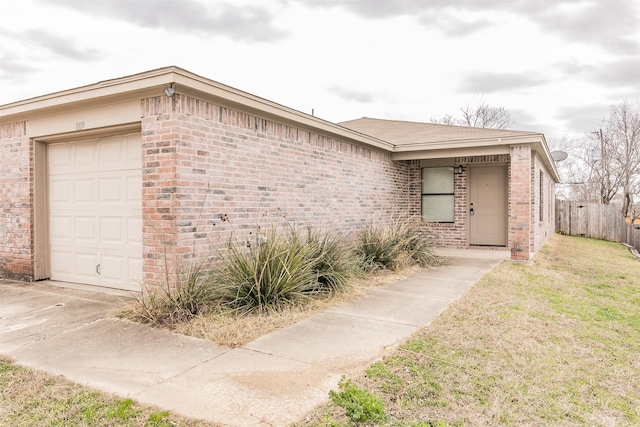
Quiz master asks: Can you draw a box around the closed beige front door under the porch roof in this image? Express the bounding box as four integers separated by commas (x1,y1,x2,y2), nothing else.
468,166,507,246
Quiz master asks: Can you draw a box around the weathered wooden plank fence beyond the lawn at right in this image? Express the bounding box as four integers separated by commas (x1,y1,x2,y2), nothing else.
556,200,640,251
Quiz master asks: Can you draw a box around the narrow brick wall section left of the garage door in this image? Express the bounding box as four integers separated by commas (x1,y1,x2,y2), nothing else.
0,122,34,280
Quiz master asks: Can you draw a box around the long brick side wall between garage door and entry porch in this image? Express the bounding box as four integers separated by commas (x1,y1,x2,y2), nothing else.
142,95,408,284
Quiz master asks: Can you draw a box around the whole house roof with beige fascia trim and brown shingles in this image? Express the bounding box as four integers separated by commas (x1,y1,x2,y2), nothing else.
0,66,558,181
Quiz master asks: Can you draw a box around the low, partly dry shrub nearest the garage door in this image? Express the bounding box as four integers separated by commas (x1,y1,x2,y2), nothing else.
131,263,215,325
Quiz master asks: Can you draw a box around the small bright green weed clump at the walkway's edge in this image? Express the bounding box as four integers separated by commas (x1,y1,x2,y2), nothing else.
329,377,388,423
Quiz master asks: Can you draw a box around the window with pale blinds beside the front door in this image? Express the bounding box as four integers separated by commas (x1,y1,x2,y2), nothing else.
422,167,454,222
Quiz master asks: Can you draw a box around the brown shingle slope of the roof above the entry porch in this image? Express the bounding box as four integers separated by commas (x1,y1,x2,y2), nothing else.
338,117,540,146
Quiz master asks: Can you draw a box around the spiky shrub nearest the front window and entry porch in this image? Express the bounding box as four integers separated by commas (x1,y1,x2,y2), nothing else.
355,216,438,271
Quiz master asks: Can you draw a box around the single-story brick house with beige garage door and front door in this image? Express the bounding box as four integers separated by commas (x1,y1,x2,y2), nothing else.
0,67,558,290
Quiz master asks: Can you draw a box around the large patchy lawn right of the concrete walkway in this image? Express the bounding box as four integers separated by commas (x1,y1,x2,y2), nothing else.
299,235,640,426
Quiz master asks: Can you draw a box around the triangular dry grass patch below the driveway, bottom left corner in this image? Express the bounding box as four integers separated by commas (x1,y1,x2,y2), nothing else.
0,356,218,427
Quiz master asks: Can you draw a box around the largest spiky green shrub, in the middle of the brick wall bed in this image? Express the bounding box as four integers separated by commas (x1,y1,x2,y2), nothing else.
215,226,317,311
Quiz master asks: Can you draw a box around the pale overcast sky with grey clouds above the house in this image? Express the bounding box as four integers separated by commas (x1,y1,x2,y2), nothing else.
0,0,640,140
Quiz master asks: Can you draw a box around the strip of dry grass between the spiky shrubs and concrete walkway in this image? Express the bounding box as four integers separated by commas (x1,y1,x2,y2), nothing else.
174,267,418,348
